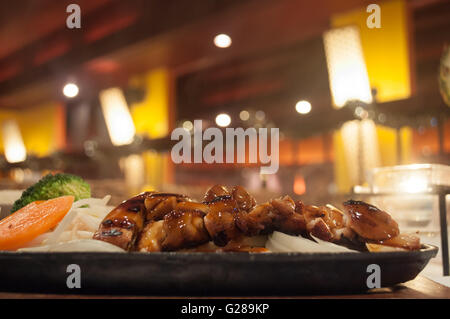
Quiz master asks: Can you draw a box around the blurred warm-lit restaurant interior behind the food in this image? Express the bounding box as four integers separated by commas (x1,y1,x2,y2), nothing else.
0,0,450,222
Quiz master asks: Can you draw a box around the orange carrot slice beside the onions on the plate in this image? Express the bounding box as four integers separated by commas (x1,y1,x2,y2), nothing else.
0,196,74,250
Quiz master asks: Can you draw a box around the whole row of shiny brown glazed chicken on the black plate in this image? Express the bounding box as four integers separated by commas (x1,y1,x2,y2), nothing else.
94,185,420,252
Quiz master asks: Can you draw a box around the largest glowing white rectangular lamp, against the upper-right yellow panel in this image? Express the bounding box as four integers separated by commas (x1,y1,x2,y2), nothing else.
323,26,372,108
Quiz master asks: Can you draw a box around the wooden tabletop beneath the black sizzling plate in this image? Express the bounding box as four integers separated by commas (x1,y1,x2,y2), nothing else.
0,276,450,299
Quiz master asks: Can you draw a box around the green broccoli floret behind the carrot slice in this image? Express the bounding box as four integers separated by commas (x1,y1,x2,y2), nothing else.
11,174,91,213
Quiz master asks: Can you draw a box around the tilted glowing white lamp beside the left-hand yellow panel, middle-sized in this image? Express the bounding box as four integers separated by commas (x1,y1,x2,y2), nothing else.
100,88,136,146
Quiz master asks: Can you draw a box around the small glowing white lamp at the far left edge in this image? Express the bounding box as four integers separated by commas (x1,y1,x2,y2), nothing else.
2,120,27,163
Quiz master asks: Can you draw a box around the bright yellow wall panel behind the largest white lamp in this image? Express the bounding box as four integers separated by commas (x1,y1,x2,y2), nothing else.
330,0,417,103
